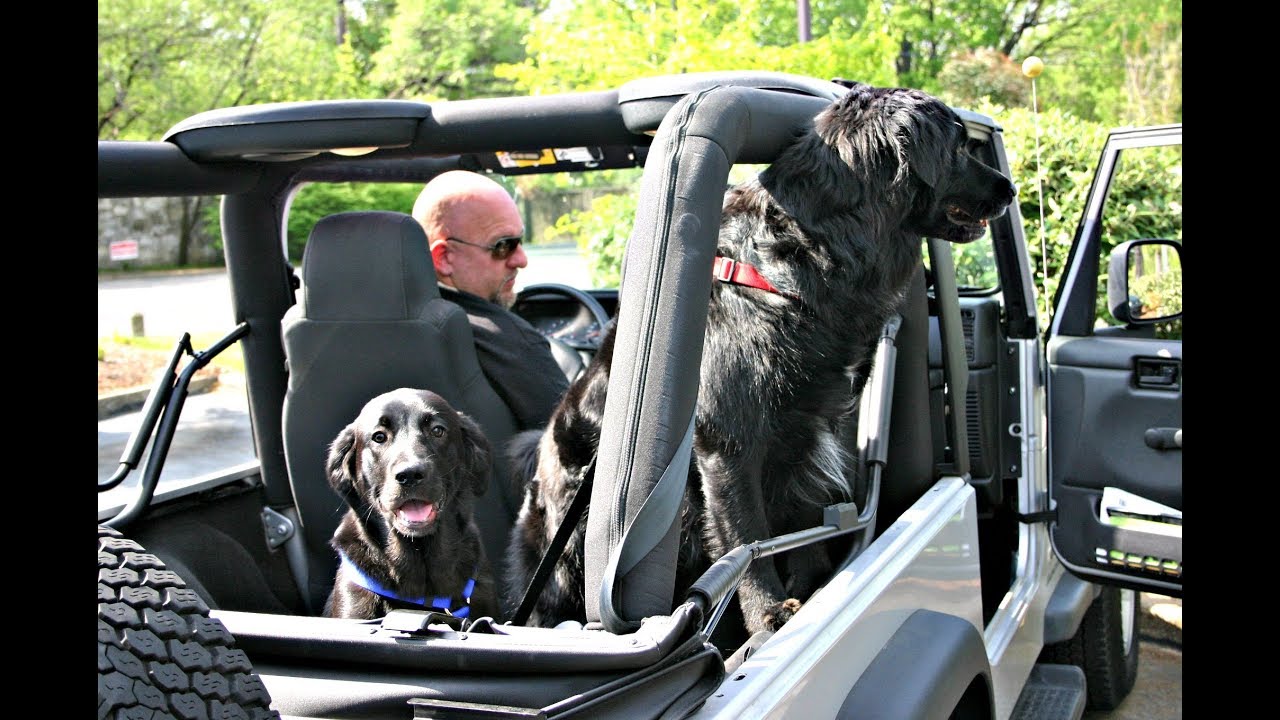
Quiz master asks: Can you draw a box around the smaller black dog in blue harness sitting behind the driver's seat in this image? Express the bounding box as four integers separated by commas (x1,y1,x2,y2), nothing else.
324,388,498,619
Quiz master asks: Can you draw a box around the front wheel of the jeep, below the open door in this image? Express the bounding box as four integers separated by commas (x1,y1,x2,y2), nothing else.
1041,587,1139,710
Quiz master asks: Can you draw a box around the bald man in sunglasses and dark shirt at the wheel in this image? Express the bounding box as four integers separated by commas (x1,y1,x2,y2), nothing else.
413,170,568,430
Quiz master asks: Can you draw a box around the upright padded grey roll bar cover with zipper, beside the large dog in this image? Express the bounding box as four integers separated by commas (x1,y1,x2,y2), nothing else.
585,86,824,633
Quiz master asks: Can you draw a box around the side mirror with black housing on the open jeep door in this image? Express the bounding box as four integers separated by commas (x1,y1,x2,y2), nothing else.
1107,238,1183,325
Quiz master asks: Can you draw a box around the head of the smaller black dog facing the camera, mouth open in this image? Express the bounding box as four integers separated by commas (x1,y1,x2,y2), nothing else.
325,388,490,538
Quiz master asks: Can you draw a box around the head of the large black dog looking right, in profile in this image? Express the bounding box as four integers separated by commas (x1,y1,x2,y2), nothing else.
814,85,1018,242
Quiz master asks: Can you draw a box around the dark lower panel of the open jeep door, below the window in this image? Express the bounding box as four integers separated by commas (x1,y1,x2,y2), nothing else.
1048,337,1183,594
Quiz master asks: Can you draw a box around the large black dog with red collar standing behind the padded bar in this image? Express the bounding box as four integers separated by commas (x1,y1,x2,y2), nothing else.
504,86,1016,633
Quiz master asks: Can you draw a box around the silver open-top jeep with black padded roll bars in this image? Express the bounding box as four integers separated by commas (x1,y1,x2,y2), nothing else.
97,72,1181,720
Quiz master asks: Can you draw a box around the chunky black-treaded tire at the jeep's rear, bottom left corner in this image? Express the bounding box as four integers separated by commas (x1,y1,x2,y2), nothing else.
97,525,280,720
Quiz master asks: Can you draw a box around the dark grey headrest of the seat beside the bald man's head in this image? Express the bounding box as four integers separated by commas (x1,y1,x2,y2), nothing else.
302,210,440,320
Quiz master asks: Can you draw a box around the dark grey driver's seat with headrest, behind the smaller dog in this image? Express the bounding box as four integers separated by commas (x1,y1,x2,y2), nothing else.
280,211,520,615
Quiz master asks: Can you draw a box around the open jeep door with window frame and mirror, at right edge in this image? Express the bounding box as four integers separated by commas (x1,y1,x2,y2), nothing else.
1046,124,1183,597
